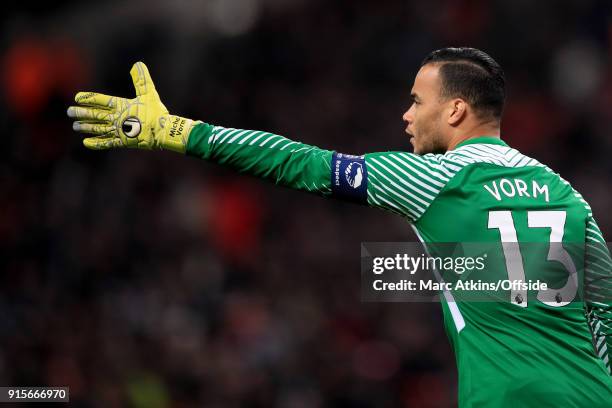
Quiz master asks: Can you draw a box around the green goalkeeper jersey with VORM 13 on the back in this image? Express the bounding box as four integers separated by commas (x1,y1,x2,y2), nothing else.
187,123,612,408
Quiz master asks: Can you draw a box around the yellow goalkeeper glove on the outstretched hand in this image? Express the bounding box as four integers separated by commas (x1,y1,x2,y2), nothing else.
68,62,199,153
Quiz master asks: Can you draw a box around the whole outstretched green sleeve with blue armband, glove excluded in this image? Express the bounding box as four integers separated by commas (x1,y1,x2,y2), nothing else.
186,123,458,214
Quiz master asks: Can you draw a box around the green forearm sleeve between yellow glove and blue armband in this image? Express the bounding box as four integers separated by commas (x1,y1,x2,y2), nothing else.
186,123,333,196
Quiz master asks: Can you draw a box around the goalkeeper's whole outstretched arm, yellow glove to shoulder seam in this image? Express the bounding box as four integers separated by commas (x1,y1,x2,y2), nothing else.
68,62,451,221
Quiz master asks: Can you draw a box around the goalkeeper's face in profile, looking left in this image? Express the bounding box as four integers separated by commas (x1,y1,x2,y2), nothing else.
402,64,447,154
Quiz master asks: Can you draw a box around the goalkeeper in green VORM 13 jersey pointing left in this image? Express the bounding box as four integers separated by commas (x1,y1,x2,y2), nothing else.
68,48,612,408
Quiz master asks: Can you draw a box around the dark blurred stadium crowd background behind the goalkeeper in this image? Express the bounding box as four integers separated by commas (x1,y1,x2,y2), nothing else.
0,0,612,408
